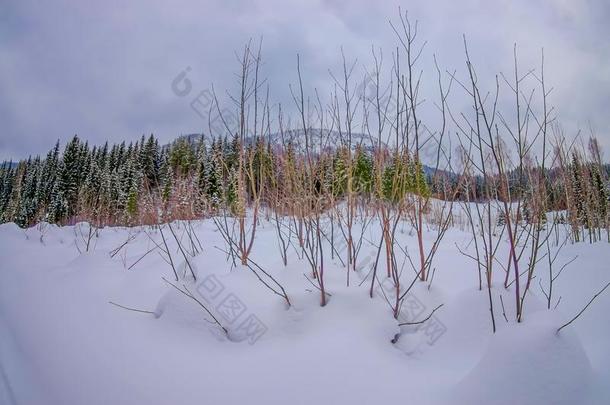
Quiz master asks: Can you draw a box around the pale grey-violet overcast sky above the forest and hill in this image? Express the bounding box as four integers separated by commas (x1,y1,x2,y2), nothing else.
0,0,610,160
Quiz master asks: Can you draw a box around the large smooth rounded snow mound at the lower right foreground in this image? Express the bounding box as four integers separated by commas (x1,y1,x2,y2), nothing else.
453,312,592,404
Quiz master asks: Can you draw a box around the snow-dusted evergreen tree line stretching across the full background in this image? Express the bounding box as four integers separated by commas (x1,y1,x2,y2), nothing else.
0,135,610,232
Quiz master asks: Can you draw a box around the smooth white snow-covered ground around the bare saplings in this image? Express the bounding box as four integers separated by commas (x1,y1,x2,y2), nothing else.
0,208,610,405
